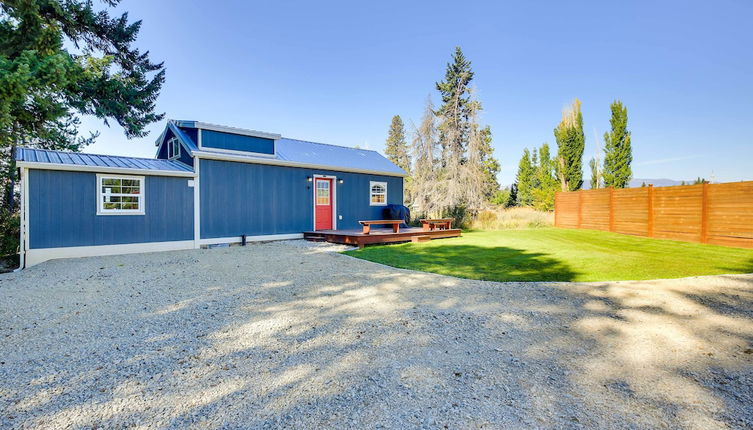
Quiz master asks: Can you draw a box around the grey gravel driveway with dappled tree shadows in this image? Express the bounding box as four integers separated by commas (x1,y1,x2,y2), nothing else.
0,241,753,429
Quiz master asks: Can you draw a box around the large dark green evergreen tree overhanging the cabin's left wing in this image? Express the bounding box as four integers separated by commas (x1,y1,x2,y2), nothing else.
0,0,165,212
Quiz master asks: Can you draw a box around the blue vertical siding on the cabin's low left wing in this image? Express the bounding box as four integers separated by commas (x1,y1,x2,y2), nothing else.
29,169,193,249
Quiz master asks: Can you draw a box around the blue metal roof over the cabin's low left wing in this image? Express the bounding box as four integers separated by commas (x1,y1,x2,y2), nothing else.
15,147,193,172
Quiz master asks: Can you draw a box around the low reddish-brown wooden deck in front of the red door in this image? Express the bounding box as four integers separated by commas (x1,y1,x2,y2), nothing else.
303,227,461,248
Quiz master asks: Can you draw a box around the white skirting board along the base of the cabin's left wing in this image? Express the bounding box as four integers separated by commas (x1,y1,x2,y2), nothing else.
26,240,194,267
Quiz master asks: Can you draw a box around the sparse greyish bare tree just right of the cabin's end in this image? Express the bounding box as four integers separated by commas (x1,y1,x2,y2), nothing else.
411,97,438,216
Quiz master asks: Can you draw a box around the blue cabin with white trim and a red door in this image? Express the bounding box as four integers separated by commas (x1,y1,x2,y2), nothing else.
15,121,405,267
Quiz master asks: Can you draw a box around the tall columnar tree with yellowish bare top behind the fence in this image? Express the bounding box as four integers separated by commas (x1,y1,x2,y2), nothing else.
554,99,586,191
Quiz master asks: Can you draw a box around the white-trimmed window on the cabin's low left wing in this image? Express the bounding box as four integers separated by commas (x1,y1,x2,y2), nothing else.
97,175,144,215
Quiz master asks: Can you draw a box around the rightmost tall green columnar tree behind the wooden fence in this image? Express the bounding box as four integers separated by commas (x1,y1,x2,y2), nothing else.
604,100,633,188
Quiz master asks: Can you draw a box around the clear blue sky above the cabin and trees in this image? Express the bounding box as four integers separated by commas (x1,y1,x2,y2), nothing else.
85,0,753,184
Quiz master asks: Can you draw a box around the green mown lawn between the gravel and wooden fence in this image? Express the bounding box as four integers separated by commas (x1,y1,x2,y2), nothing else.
346,228,753,281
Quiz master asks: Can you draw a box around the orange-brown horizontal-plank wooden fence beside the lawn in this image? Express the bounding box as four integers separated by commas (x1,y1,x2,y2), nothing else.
554,182,753,248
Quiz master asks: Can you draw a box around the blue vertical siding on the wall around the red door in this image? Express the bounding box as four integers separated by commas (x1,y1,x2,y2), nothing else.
199,158,403,239
